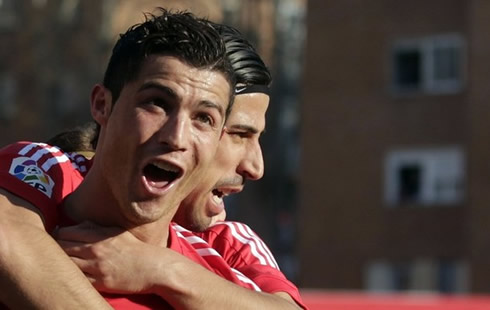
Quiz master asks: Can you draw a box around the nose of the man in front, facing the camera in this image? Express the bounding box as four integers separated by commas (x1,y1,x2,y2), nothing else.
159,113,190,150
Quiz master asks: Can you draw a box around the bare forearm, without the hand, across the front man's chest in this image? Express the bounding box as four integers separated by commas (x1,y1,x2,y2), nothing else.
153,253,300,310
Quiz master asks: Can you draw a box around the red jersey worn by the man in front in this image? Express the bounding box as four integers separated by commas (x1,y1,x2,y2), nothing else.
0,142,258,309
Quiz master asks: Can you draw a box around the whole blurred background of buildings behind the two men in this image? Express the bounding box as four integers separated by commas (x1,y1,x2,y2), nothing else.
0,0,490,306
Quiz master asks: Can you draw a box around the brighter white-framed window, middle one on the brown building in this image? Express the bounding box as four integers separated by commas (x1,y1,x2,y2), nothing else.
385,147,465,206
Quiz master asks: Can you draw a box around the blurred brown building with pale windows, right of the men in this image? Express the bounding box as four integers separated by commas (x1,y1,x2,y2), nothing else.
298,0,490,292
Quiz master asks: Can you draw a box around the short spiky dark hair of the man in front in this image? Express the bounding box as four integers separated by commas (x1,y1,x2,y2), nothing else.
92,8,235,148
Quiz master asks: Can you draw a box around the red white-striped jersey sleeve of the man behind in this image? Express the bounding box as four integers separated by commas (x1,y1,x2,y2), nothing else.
197,221,307,309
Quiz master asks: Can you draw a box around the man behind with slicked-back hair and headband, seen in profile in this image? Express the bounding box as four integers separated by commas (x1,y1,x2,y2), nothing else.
50,25,306,309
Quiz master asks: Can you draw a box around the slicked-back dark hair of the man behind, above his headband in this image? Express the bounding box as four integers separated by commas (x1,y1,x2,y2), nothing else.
214,24,272,87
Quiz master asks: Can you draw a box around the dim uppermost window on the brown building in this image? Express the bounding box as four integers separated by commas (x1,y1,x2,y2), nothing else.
393,34,465,94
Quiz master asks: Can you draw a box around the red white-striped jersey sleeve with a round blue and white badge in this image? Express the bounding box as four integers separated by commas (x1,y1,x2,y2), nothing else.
0,142,88,231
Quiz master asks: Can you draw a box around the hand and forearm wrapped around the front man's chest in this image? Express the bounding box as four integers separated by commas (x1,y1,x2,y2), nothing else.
58,223,298,310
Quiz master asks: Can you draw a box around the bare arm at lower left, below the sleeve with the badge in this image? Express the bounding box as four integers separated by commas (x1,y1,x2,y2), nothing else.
0,191,110,309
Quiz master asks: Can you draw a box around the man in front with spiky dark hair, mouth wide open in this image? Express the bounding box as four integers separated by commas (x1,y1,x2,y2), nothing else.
0,9,268,309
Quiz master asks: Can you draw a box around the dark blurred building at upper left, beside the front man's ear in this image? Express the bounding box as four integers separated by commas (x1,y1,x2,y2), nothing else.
0,0,107,145
